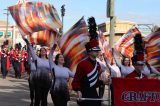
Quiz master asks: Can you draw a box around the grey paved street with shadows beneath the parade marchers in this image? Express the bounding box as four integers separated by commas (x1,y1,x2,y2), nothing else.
0,71,107,106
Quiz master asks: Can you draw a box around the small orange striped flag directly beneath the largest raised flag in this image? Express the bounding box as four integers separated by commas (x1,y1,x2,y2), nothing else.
29,30,60,47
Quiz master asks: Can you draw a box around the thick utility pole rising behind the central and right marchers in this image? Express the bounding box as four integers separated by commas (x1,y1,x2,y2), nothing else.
107,0,116,47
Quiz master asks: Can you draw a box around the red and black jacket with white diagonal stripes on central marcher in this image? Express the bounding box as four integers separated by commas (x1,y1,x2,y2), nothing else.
72,58,101,91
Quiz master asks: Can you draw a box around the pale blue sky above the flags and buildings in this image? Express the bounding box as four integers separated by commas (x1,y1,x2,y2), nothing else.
0,0,160,32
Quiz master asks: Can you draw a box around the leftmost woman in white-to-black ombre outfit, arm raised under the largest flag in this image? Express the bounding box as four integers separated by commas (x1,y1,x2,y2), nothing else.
23,38,51,106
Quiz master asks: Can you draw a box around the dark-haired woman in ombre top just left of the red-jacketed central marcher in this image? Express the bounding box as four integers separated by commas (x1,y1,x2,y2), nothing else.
49,44,74,106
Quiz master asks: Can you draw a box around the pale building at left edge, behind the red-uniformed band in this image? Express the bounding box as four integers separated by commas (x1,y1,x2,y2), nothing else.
0,20,25,47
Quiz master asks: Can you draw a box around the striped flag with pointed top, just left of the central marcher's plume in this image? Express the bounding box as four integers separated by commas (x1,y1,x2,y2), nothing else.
59,17,89,71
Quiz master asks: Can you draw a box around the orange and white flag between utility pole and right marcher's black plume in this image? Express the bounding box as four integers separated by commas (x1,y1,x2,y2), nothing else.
115,27,141,57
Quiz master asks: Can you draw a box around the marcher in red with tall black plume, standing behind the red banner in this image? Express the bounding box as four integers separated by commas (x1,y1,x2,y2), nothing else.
126,34,147,78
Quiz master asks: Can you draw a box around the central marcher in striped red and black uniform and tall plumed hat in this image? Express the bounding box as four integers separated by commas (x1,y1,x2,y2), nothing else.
72,17,101,106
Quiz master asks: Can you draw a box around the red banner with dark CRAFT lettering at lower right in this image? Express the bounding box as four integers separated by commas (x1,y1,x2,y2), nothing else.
112,78,160,106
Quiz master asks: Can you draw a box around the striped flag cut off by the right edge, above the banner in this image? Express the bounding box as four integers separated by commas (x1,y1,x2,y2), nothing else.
144,31,160,72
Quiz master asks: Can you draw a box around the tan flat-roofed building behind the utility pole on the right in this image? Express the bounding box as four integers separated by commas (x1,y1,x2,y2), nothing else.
98,21,154,43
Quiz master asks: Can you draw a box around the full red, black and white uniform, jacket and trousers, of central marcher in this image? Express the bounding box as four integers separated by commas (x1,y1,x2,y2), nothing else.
72,58,101,106
